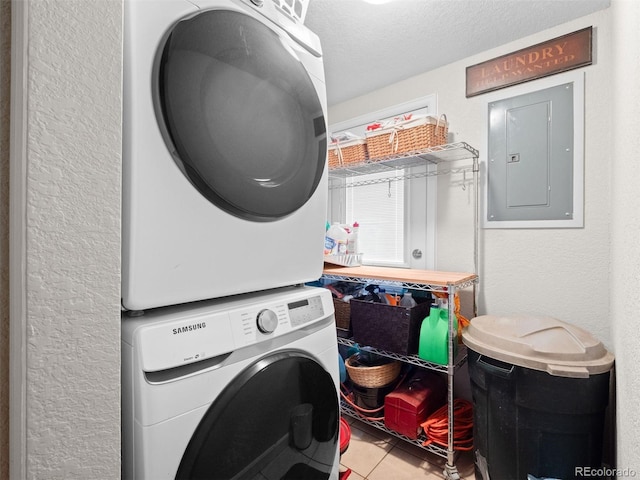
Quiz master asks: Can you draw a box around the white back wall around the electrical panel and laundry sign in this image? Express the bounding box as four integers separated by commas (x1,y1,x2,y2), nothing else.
329,10,611,347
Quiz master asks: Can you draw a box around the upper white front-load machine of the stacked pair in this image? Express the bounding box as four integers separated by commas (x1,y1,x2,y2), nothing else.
122,0,327,310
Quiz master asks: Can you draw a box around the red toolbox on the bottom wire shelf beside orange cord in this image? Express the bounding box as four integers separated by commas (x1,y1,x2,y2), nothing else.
384,370,447,440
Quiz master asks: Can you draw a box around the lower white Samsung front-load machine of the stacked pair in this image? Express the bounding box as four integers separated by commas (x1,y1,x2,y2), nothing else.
122,287,340,480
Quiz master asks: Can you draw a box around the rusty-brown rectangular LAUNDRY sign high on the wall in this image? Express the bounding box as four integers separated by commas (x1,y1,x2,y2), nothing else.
467,27,593,97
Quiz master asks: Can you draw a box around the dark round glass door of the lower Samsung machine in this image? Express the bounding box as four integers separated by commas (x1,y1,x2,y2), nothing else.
176,351,340,480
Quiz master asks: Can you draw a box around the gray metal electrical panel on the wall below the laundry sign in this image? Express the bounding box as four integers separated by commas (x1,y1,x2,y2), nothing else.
487,83,574,222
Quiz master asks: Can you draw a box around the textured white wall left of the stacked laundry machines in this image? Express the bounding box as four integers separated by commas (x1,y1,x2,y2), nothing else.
8,0,122,480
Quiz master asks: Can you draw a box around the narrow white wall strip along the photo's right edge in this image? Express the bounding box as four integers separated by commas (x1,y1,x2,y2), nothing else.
610,0,640,472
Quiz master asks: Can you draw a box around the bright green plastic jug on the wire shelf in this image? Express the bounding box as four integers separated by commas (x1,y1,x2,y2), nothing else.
418,307,458,365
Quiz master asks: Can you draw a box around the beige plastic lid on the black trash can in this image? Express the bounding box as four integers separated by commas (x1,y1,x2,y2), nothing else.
462,315,614,378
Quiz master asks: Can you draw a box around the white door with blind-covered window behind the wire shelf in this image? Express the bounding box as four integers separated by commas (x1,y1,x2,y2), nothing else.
328,95,437,269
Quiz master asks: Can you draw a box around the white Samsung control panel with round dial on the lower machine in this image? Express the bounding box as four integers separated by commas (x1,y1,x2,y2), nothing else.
128,287,333,372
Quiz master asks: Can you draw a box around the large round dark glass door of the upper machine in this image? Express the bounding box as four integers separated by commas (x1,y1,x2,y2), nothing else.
156,10,327,221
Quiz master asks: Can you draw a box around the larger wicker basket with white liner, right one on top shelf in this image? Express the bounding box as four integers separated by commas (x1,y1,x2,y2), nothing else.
367,114,449,160
